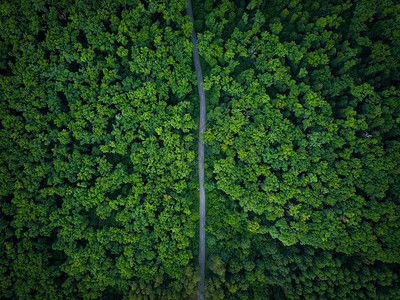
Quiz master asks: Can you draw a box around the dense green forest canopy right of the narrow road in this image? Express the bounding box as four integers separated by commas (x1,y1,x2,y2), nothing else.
198,1,400,299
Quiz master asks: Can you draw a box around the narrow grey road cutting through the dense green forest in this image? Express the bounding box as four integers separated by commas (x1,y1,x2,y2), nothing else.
187,0,206,300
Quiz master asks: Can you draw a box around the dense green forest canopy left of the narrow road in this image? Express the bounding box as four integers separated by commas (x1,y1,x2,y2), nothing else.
0,1,199,299
